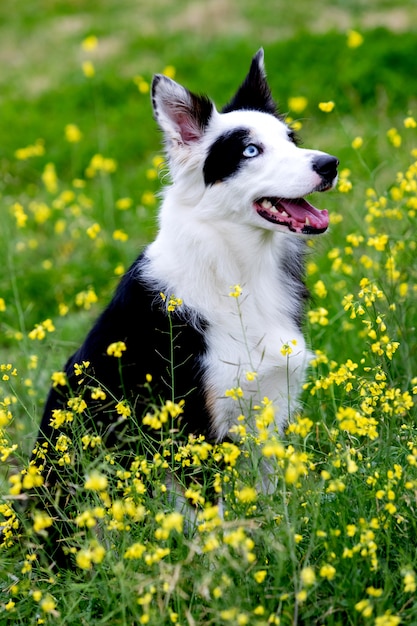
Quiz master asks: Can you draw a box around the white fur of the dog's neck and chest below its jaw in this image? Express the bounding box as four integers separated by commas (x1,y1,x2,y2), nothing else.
147,224,308,440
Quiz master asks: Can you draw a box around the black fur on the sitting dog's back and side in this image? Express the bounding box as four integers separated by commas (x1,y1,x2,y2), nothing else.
40,254,210,449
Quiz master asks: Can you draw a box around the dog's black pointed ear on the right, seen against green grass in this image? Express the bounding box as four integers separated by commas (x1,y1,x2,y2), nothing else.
222,48,277,115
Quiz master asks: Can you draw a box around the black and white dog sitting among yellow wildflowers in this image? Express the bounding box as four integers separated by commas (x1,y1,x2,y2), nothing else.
40,50,338,468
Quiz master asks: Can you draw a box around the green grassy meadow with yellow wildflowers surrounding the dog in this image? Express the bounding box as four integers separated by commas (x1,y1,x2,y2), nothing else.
0,0,417,626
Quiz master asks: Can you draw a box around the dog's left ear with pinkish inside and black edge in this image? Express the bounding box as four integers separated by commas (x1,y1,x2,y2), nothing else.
152,74,214,144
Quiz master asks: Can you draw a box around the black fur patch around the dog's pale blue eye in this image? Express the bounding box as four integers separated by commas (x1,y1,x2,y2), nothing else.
203,128,251,186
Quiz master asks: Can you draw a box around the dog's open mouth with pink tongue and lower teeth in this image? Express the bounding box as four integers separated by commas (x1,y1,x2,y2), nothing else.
254,198,329,235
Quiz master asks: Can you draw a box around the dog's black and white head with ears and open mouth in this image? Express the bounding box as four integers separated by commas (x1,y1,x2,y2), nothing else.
152,50,338,235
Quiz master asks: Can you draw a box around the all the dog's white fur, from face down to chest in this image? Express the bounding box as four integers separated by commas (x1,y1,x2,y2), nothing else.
146,64,334,440
